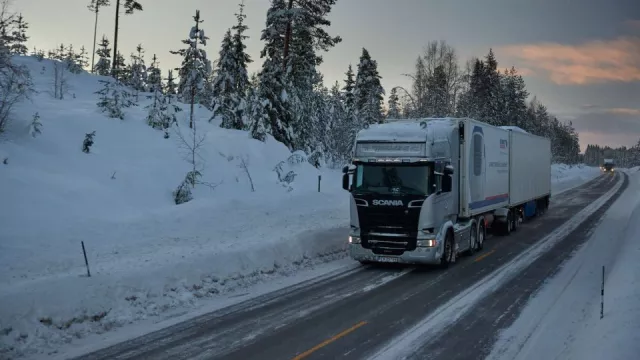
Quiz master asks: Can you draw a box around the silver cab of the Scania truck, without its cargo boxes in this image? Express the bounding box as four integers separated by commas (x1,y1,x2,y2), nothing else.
343,119,469,264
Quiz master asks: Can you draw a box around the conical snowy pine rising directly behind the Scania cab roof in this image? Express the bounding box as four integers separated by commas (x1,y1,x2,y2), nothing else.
354,48,384,124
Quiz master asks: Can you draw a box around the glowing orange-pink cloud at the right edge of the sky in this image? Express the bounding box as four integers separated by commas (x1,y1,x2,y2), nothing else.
500,36,640,85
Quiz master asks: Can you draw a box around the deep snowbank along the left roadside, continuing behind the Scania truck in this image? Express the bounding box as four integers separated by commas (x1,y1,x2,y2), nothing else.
0,54,599,357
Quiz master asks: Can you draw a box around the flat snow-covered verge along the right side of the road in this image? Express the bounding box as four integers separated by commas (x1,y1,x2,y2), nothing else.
488,168,640,360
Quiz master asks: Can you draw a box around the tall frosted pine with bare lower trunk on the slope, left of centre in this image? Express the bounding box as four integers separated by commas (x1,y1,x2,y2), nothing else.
171,10,211,128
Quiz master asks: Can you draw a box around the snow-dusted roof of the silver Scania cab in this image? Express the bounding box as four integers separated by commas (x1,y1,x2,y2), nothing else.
356,118,461,142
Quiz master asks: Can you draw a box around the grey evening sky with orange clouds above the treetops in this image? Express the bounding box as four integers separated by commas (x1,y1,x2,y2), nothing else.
13,0,640,150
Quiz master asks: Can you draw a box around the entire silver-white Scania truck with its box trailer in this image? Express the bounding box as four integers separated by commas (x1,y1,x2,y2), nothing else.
342,118,551,267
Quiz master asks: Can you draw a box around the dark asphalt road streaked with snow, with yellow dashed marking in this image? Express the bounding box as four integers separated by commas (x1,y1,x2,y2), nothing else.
71,174,627,360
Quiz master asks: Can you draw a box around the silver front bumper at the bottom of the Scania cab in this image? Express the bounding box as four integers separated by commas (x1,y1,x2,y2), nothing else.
349,244,442,265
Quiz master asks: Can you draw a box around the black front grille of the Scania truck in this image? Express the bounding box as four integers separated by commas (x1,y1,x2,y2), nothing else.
358,206,420,255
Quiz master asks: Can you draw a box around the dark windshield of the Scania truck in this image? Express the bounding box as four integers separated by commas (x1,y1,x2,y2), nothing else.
353,164,433,196
